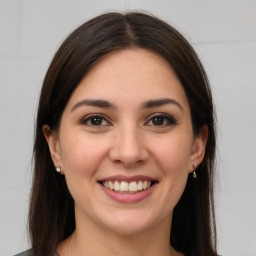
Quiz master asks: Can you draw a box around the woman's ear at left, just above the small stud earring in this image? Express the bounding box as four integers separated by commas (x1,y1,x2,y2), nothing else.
42,125,61,167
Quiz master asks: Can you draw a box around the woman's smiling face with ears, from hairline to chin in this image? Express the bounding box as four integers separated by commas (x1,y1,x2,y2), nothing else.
44,49,207,234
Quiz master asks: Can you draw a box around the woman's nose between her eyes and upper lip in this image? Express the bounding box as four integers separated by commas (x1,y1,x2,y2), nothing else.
109,124,148,168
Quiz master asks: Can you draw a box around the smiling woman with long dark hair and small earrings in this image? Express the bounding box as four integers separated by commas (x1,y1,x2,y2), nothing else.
16,13,217,256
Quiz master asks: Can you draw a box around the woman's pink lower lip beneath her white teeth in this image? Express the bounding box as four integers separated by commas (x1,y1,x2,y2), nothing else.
100,183,157,204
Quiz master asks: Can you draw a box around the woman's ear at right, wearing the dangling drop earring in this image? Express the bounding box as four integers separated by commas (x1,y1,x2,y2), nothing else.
189,125,208,172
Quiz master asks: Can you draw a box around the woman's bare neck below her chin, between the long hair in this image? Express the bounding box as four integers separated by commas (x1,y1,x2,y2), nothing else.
58,206,182,256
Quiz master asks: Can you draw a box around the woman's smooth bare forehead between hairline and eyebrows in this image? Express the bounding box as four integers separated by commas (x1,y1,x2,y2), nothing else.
65,49,188,111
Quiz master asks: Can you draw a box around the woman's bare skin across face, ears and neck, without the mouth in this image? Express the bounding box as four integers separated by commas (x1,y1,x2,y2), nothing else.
43,49,207,256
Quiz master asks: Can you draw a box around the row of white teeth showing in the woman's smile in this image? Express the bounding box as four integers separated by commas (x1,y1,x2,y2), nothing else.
102,180,151,192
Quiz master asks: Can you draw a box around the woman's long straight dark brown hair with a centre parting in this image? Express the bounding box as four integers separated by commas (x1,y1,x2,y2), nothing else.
29,12,217,256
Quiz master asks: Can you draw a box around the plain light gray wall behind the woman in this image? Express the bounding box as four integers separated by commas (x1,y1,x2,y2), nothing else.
0,0,256,256
